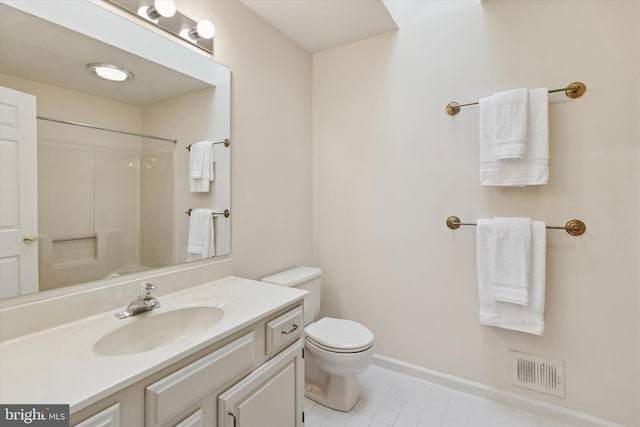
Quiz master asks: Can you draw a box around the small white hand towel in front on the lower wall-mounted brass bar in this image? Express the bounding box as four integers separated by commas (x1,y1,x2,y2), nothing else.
492,217,531,305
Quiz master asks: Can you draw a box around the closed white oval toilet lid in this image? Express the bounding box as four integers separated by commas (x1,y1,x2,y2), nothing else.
304,317,373,352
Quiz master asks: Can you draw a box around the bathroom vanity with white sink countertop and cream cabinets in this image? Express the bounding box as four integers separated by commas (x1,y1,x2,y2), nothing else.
0,270,304,427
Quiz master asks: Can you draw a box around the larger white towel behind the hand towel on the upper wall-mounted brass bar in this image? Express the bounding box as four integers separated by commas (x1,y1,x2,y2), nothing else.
479,88,549,187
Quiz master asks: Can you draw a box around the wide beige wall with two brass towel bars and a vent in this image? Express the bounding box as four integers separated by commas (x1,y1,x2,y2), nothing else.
313,0,640,425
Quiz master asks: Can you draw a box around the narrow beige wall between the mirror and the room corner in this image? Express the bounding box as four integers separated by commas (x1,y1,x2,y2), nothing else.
176,0,312,279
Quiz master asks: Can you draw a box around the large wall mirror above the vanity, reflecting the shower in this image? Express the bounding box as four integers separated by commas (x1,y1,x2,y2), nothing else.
0,4,230,297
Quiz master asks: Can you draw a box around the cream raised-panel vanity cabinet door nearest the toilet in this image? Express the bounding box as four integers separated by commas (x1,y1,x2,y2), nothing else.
218,340,304,427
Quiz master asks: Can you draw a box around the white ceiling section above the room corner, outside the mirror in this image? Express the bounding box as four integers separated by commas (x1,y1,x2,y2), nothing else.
240,0,398,53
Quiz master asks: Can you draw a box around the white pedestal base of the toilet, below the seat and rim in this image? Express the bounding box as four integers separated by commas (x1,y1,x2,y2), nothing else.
304,357,361,412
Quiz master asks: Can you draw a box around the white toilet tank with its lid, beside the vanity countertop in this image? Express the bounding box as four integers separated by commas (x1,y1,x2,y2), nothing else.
262,267,322,325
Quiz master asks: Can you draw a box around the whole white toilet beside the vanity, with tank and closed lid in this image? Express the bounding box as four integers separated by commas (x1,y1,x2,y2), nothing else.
262,267,373,412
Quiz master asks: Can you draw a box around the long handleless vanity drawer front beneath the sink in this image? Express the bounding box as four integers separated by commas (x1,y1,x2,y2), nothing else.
145,332,255,427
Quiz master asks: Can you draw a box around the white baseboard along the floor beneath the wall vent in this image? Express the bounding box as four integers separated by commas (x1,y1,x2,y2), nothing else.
373,353,624,427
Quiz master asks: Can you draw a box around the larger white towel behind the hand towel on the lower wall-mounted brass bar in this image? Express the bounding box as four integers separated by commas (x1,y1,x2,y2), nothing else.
476,219,546,335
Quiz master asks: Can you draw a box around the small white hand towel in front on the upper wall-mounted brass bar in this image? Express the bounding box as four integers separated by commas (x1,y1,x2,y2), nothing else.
492,89,529,160
